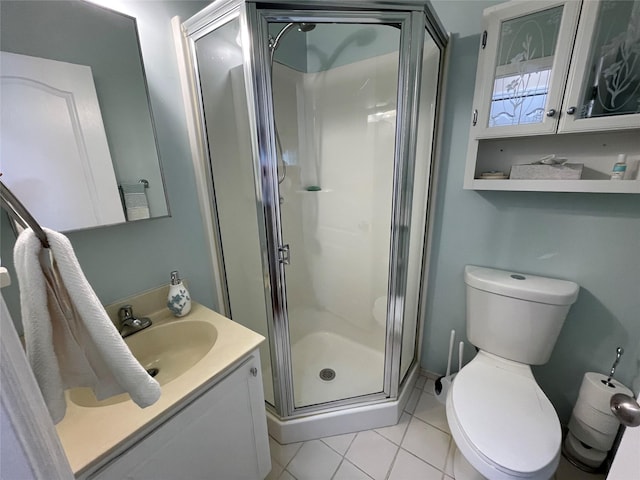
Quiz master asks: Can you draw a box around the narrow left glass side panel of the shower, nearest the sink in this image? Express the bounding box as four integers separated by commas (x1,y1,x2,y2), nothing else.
193,15,276,405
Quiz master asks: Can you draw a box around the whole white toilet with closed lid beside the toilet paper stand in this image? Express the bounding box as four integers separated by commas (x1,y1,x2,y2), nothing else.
446,265,579,480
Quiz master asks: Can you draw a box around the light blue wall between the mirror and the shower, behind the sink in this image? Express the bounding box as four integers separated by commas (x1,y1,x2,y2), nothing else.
1,1,215,330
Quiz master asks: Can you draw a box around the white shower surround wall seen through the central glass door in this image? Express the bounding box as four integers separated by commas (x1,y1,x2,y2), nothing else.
273,52,398,349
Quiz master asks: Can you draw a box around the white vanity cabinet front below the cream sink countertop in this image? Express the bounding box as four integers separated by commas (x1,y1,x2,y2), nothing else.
85,350,271,480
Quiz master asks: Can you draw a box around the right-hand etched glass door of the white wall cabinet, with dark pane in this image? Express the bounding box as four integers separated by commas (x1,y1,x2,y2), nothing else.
559,0,640,132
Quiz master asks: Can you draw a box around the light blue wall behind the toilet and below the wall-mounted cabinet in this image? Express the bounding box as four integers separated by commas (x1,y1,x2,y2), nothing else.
422,1,640,421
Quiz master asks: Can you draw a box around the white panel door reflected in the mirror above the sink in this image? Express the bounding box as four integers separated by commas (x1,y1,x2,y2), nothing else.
0,52,125,231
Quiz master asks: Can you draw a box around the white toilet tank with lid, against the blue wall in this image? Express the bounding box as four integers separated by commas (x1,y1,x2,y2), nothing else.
464,265,580,365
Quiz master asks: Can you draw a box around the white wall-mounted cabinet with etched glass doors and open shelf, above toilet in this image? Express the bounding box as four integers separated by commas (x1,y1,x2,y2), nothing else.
464,0,640,193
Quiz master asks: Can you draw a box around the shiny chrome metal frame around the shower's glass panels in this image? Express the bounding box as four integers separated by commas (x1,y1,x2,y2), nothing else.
182,0,448,419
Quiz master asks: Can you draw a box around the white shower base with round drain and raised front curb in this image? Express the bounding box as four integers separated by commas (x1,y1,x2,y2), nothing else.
263,308,417,444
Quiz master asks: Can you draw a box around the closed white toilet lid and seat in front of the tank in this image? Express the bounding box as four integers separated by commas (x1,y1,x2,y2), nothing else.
446,351,562,480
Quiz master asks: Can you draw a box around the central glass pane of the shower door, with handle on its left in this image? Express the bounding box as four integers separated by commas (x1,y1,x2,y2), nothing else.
269,22,400,408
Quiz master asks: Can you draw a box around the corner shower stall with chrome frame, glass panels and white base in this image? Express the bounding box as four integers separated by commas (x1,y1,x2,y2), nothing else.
175,0,447,443
